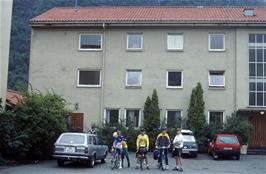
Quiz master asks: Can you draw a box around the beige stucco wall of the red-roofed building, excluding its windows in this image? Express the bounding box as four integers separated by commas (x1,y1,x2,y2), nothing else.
29,27,261,128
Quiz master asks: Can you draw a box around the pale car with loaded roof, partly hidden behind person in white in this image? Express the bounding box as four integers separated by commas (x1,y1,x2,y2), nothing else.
181,129,198,158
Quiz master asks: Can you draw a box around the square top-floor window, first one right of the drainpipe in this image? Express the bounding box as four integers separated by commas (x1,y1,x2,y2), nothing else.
127,34,143,50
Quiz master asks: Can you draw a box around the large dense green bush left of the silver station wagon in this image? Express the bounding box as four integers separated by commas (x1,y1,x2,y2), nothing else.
0,92,68,160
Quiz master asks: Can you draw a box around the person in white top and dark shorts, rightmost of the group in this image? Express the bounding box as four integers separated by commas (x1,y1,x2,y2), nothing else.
173,128,183,172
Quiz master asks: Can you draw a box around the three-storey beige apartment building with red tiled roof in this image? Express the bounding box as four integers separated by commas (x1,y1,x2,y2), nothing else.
29,7,266,147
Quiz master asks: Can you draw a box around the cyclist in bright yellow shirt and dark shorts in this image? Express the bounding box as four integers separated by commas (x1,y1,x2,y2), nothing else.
136,128,150,169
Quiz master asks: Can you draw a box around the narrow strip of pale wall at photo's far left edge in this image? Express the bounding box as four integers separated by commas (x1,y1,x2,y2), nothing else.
0,0,13,106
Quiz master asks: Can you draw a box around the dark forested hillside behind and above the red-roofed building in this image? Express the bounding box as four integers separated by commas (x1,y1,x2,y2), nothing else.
8,0,266,90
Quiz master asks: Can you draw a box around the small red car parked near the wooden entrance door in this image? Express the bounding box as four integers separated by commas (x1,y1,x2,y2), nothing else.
208,134,240,160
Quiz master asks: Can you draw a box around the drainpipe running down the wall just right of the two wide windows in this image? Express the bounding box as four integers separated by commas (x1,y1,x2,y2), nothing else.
100,23,106,124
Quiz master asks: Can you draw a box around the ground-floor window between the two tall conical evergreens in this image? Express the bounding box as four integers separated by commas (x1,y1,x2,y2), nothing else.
166,110,182,128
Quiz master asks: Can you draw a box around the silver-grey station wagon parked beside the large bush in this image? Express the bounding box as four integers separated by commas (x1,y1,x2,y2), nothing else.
53,133,108,167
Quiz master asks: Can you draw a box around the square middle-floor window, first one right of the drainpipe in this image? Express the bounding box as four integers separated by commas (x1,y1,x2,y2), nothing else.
126,70,142,87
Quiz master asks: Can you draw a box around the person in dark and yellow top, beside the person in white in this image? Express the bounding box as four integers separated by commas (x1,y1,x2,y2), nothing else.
155,127,170,170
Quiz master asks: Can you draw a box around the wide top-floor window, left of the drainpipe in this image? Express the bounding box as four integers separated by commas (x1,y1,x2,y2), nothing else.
79,34,102,50
